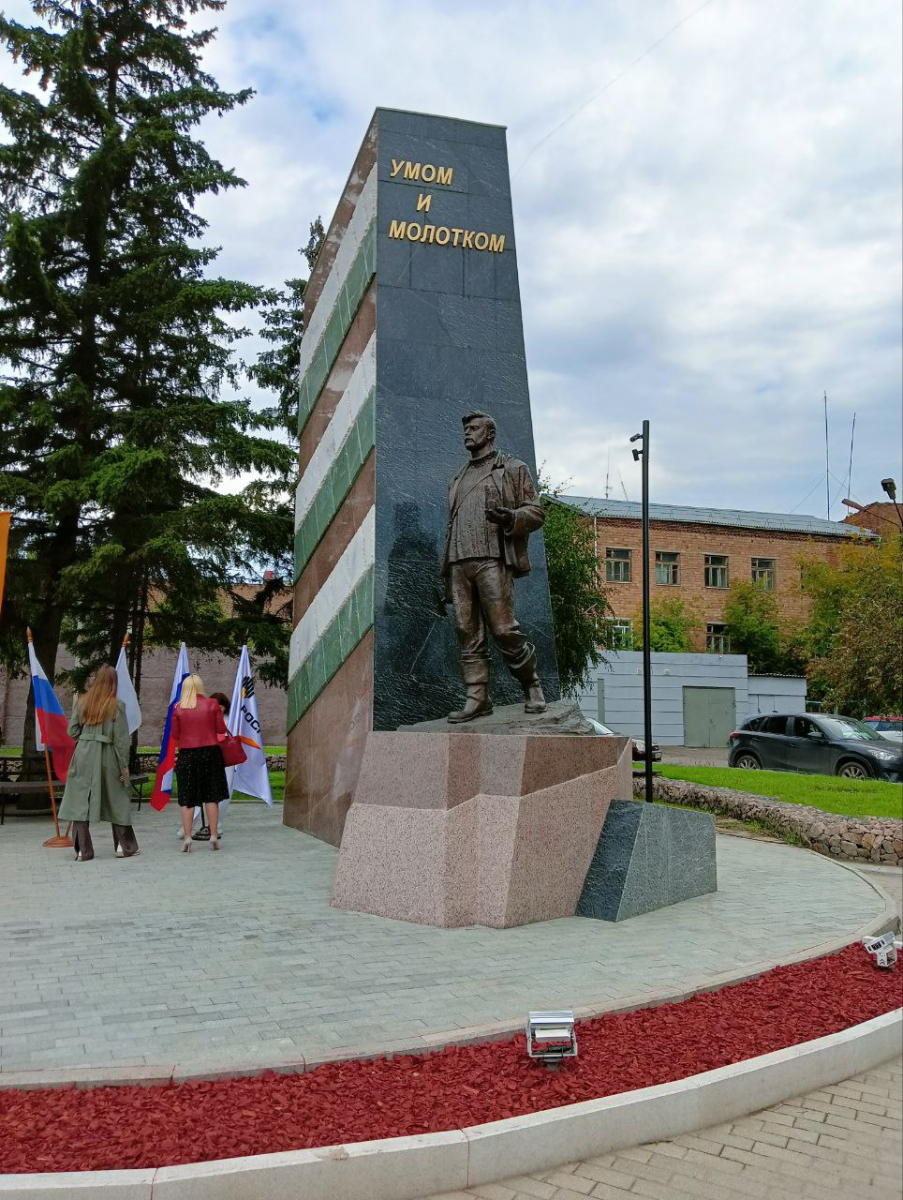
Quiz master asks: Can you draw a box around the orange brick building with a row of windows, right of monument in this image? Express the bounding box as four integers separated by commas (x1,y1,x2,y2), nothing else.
561,496,868,653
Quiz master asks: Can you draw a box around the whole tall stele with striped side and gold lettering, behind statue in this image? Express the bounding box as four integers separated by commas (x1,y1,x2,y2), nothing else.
285,109,560,842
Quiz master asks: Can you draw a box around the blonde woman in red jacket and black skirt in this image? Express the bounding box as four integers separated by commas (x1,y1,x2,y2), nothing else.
172,676,229,854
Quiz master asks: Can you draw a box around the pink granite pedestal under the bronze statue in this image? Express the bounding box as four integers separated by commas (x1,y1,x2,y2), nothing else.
333,732,633,928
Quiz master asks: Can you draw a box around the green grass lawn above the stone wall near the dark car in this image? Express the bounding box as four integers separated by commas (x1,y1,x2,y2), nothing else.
659,766,903,817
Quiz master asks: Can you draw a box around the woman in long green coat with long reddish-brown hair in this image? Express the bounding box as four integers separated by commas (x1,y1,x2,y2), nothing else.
60,666,138,863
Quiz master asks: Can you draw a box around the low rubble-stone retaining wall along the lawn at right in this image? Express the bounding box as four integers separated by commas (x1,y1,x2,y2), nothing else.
633,776,903,866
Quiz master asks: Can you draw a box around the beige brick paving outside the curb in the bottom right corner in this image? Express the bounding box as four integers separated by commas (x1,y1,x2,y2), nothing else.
430,1058,903,1200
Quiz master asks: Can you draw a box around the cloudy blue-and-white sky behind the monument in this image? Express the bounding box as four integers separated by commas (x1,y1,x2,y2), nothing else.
4,0,903,517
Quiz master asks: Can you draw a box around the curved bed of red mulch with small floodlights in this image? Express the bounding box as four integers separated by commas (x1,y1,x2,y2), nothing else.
0,946,903,1172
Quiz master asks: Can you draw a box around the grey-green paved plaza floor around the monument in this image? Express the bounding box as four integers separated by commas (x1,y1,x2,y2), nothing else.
0,805,884,1072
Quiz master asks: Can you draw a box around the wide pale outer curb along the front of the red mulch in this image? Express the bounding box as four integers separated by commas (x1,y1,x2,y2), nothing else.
0,1009,903,1200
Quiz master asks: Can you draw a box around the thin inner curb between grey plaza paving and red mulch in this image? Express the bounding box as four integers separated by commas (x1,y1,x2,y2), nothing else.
0,847,901,1091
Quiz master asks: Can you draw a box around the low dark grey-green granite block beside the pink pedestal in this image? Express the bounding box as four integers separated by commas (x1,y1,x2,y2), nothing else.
576,800,718,920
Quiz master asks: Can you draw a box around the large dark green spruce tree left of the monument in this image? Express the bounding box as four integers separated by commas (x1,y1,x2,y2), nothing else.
0,0,294,743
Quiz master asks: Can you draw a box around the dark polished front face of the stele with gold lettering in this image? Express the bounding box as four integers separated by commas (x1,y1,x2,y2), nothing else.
373,112,558,730
